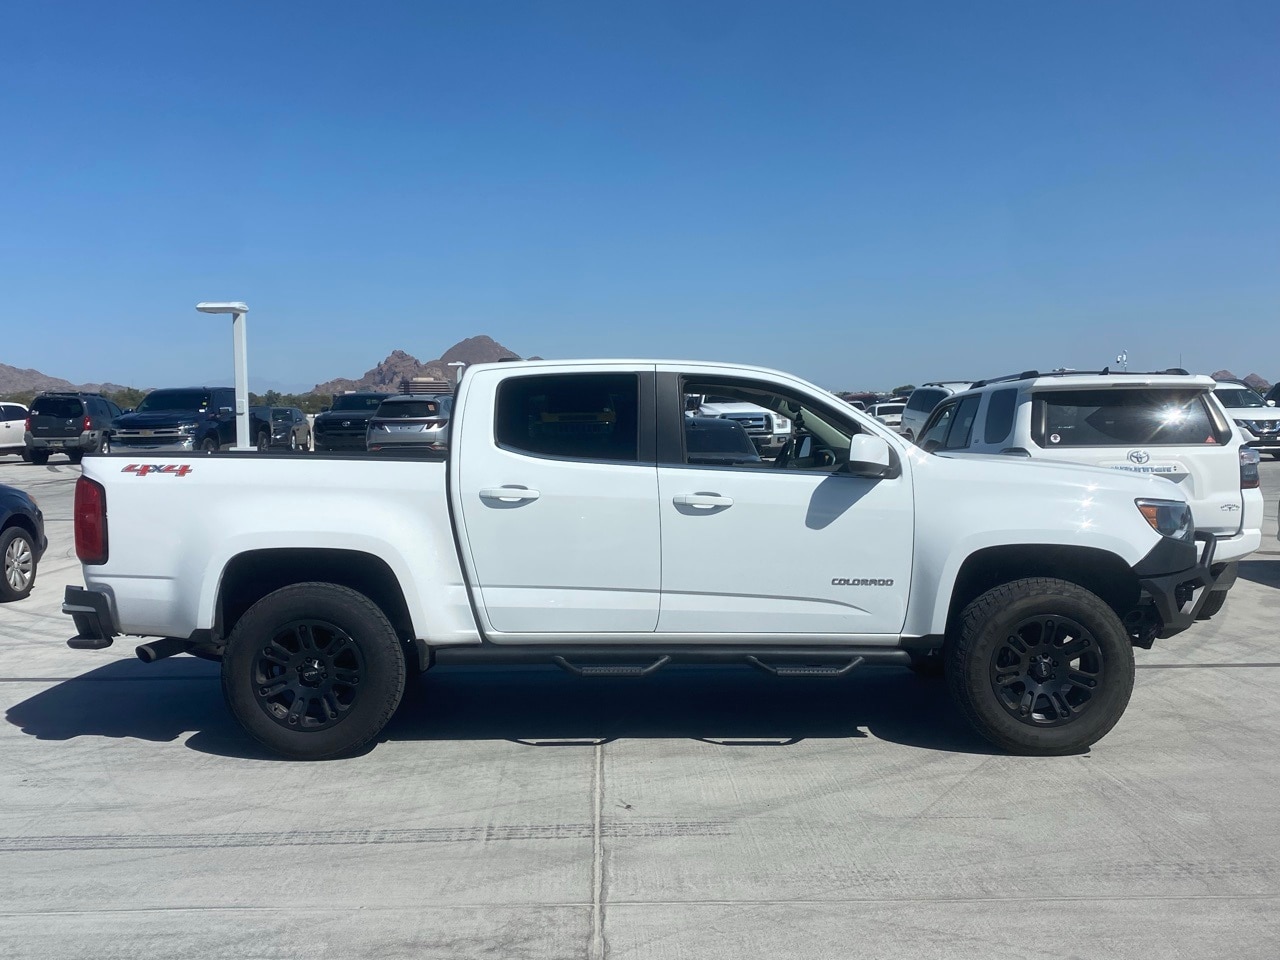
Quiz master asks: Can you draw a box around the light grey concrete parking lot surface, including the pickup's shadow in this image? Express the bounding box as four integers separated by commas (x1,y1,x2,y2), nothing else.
0,457,1280,960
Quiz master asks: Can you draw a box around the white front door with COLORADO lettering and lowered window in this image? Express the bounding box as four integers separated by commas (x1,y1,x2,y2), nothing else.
658,367,914,640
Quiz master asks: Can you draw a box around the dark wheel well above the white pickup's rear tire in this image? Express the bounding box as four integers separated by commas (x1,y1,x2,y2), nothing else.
214,548,413,641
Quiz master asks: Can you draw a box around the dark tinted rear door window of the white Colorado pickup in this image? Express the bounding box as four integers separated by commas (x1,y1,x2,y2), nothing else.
494,374,640,462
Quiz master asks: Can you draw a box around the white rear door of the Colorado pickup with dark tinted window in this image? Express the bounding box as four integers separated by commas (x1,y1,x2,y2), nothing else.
451,365,662,643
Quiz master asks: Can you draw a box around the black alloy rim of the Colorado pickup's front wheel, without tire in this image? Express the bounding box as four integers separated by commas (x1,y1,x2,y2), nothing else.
991,614,1105,727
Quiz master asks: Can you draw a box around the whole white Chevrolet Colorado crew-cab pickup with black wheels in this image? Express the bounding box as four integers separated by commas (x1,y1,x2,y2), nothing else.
63,361,1234,759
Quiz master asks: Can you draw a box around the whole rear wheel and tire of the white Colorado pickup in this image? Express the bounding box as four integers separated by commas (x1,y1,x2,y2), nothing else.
223,584,404,760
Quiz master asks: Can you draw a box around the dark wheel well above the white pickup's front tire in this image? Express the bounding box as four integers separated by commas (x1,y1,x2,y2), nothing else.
947,544,1139,636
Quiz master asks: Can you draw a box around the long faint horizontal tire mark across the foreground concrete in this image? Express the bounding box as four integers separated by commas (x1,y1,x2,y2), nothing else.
0,820,730,854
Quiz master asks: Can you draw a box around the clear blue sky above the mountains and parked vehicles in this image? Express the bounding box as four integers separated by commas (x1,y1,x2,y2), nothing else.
0,0,1280,388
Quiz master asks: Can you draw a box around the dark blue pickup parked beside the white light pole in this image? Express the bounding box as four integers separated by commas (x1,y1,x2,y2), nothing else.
113,387,270,453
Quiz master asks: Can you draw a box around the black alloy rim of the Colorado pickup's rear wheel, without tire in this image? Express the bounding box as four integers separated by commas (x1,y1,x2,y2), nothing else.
253,620,365,731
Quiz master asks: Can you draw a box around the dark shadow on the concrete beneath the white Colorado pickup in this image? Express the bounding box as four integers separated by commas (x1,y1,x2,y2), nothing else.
5,657,997,760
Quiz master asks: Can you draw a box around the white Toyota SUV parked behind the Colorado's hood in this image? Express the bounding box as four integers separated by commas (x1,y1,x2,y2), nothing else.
916,370,1262,616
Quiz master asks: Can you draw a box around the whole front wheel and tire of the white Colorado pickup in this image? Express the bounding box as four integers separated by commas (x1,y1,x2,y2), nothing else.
946,577,1134,756
